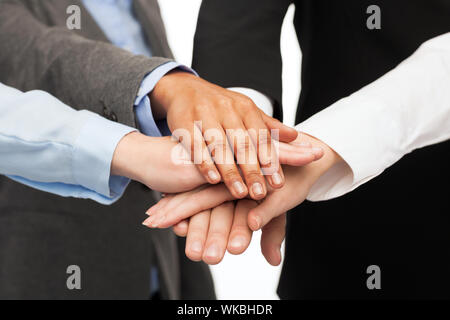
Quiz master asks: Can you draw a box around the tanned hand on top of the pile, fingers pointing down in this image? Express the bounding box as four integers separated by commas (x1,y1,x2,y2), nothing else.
150,71,297,199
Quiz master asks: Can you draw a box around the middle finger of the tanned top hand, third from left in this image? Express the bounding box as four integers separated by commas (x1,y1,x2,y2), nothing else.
224,118,267,200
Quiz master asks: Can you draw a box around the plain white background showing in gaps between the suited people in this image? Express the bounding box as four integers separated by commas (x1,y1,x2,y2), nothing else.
159,0,301,299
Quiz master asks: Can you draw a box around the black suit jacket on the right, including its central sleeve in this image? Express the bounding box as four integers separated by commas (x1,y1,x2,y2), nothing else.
193,0,450,299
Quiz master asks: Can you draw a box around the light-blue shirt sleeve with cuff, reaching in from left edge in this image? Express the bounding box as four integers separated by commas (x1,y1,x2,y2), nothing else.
0,84,136,204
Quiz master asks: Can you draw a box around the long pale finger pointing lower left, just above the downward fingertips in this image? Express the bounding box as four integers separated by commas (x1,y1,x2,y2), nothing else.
152,184,234,228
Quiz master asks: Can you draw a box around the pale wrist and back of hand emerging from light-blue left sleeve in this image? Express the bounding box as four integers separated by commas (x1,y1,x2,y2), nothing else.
111,132,206,193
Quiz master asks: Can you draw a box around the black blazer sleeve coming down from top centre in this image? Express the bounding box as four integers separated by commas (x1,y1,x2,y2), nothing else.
193,0,292,119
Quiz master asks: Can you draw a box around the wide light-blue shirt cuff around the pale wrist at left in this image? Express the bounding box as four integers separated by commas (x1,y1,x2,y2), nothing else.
72,111,136,199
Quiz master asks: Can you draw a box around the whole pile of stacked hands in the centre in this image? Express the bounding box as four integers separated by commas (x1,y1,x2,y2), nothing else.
111,72,340,265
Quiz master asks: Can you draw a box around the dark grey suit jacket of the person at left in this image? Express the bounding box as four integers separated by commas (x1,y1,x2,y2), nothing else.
0,0,214,299
